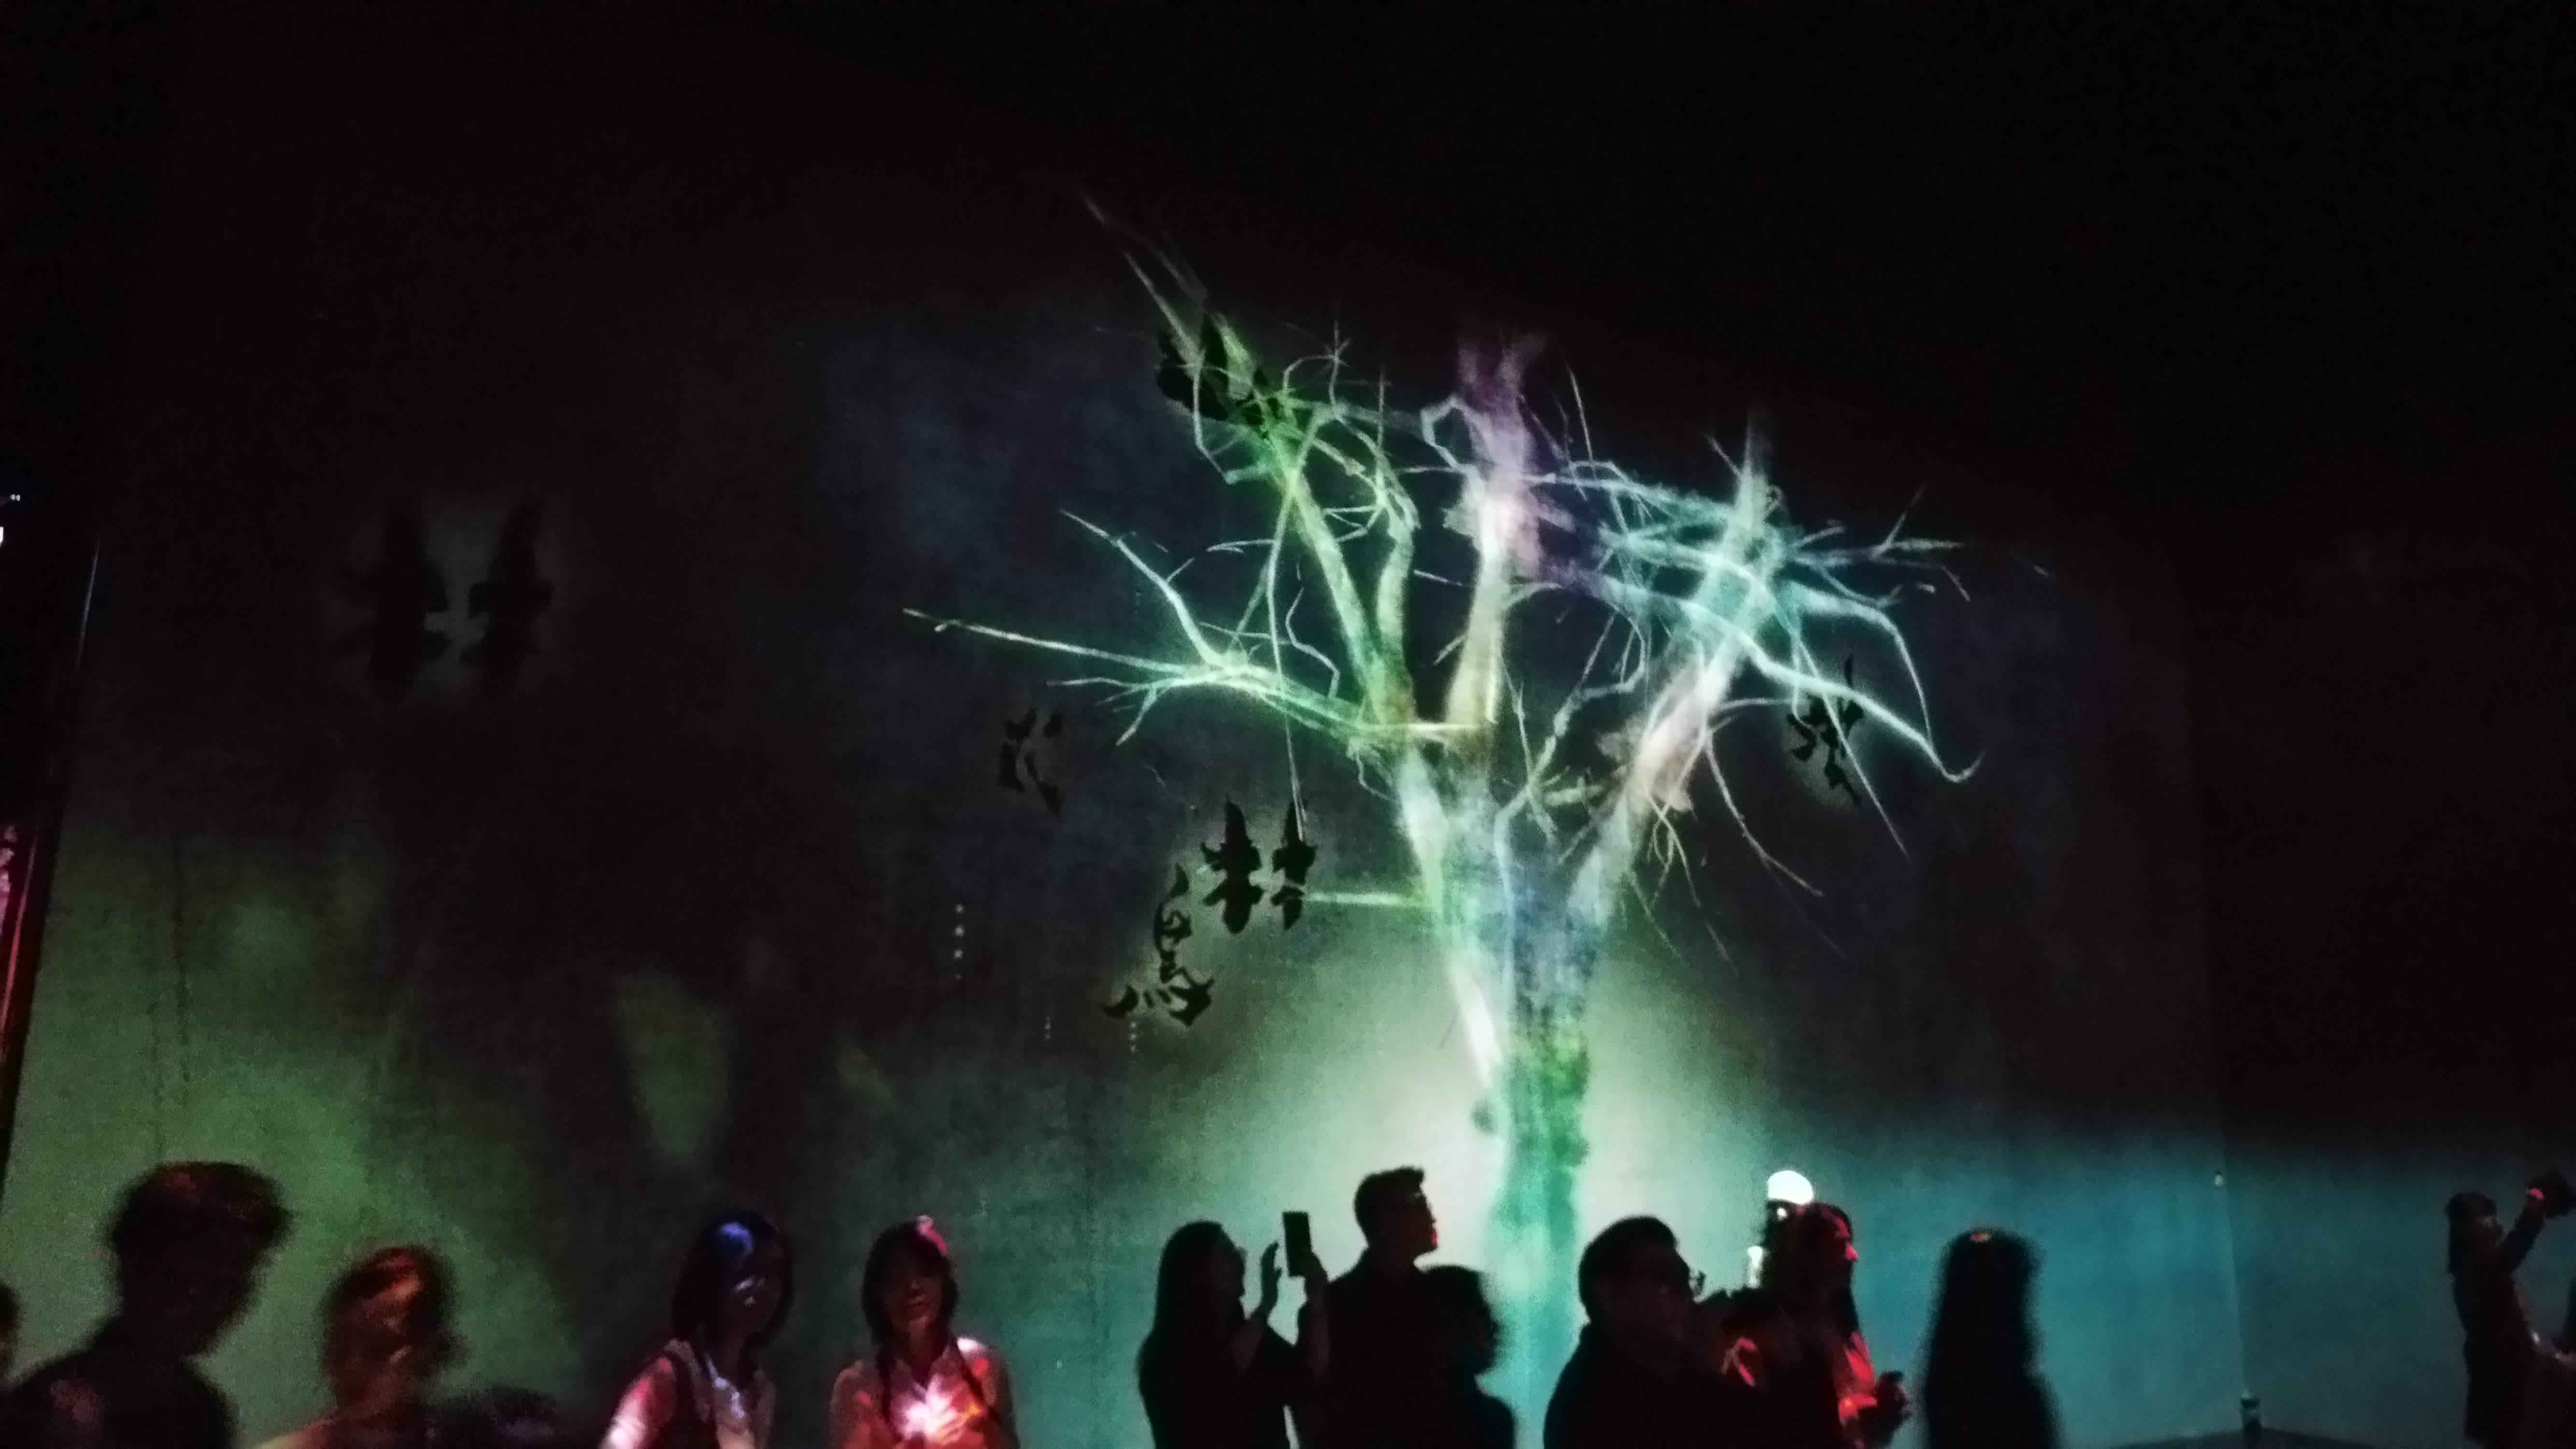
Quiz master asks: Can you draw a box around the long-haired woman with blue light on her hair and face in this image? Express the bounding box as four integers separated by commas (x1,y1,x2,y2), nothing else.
600,1212,796,1449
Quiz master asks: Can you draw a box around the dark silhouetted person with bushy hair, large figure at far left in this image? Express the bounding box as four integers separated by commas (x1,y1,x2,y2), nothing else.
0,1164,286,1449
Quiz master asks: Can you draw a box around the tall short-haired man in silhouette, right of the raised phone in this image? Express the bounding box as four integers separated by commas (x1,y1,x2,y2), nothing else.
1324,1168,1440,1449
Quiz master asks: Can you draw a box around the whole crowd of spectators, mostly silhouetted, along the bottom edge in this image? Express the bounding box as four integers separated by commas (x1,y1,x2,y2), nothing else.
20,1164,2576,1449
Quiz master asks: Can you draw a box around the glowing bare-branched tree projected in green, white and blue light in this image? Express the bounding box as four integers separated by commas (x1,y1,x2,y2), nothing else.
914,244,1968,1372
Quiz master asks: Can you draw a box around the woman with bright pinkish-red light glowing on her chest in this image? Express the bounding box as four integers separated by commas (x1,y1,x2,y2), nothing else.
829,1217,1020,1449
